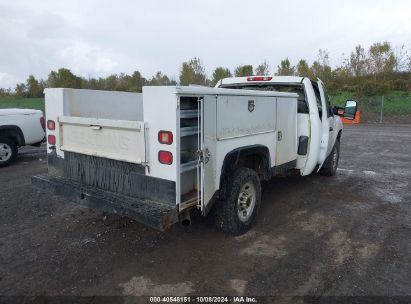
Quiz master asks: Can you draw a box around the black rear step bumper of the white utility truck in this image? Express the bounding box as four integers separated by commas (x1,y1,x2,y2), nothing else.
32,175,178,231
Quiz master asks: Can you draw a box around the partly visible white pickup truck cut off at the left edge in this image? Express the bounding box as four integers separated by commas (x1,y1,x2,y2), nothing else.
0,109,45,167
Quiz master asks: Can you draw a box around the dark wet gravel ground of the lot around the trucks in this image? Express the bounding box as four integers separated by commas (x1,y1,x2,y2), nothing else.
0,125,411,301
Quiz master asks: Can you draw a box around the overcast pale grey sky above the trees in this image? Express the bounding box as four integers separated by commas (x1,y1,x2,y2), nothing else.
0,0,411,88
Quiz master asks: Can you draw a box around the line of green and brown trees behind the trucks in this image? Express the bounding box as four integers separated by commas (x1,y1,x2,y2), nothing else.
0,42,411,97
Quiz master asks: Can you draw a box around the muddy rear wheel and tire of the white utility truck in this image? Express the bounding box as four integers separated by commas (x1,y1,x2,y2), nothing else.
213,168,261,235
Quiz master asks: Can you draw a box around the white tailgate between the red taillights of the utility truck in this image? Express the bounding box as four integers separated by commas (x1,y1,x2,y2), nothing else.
59,116,146,164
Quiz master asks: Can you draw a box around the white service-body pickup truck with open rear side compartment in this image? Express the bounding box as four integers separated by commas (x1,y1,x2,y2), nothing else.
32,76,355,234
